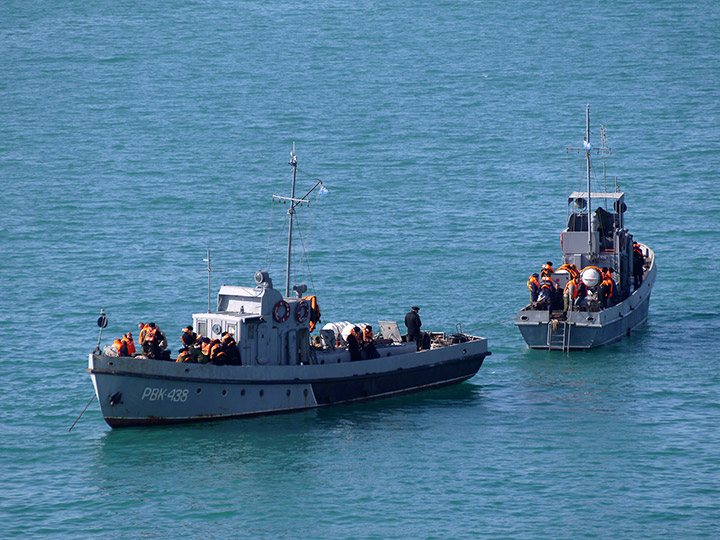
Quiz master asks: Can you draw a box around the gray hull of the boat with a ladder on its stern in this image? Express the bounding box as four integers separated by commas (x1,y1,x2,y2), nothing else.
515,252,656,350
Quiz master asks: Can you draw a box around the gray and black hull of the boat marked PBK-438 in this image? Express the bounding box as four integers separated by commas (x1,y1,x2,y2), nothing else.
88,339,490,428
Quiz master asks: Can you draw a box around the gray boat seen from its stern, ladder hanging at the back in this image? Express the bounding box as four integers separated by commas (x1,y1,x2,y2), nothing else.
515,105,657,351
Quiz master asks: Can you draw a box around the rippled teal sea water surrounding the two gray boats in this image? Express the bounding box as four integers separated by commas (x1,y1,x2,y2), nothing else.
0,0,720,540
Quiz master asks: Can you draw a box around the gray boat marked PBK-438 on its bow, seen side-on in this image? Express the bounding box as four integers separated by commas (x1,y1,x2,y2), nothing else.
88,152,490,428
